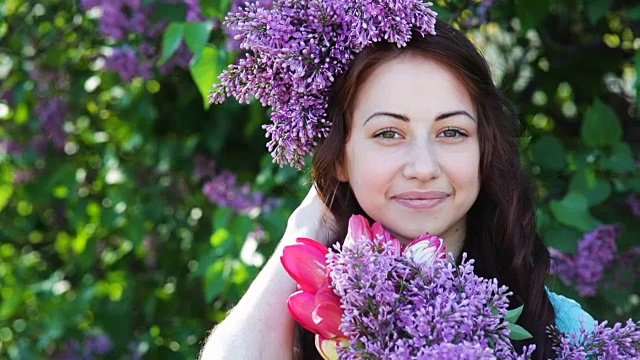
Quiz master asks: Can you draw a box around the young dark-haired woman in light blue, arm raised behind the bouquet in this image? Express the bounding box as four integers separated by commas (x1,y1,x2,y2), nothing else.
202,22,593,359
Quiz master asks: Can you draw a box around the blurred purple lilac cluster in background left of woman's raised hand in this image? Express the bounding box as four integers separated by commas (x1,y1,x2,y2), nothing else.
194,156,280,213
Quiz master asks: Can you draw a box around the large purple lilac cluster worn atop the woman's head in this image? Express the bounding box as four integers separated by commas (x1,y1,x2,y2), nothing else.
209,0,437,168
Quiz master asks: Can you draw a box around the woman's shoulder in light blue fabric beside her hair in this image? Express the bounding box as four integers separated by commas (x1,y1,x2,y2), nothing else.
547,289,595,334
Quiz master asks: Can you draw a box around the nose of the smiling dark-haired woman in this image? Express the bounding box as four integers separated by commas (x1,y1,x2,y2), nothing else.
403,141,442,181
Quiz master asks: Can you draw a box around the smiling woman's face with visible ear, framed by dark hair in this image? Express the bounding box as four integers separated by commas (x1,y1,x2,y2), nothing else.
338,54,480,254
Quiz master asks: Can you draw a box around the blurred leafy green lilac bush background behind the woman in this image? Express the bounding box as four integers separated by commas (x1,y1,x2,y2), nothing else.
0,0,640,359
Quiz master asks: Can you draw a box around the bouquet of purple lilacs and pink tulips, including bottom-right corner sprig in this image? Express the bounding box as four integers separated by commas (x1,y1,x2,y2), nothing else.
282,216,640,360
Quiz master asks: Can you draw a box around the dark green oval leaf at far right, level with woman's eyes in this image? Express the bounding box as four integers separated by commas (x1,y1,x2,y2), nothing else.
580,99,622,148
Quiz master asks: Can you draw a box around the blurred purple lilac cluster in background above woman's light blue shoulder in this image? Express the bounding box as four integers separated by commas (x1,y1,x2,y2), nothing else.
549,225,619,296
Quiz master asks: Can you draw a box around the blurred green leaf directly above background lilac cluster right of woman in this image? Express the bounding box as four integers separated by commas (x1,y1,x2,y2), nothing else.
550,192,598,232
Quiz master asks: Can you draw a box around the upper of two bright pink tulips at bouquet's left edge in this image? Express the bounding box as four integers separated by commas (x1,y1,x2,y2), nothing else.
280,243,329,293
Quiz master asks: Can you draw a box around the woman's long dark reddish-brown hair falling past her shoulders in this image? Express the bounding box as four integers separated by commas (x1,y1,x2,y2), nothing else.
299,22,555,359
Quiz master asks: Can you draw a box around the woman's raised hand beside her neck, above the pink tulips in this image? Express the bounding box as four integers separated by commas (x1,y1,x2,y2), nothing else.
283,185,336,246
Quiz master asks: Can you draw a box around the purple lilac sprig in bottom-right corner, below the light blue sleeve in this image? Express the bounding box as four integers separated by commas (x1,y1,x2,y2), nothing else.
548,319,640,360
